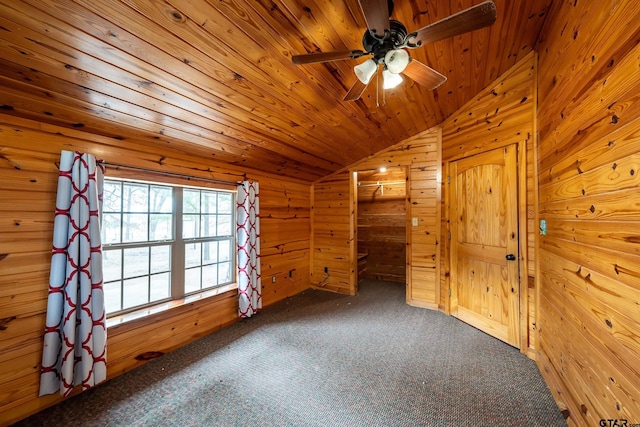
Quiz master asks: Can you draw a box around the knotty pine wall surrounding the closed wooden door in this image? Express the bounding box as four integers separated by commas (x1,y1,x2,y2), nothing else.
440,52,537,357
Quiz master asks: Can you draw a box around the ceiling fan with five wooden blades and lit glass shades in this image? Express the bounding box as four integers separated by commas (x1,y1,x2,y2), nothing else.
291,0,496,101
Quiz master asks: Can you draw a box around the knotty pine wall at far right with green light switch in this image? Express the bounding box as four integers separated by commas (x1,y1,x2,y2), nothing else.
538,0,640,426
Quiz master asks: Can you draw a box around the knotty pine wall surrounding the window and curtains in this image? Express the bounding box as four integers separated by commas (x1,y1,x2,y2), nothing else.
0,115,310,425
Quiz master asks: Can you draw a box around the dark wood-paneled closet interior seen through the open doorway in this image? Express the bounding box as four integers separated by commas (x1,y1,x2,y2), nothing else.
357,167,407,283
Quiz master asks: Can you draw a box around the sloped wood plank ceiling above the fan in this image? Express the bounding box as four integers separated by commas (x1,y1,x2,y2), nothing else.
0,0,551,181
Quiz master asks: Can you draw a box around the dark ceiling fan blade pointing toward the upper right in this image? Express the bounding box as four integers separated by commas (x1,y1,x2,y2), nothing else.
409,0,497,44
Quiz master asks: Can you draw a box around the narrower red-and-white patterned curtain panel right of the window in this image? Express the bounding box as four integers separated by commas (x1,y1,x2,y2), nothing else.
236,181,262,317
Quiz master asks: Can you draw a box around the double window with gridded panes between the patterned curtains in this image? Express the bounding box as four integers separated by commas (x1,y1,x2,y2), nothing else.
102,179,235,315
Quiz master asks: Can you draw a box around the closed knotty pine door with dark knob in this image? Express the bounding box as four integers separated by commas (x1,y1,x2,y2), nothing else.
451,145,520,347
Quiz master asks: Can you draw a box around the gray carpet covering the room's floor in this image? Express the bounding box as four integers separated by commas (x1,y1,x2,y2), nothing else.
13,281,566,427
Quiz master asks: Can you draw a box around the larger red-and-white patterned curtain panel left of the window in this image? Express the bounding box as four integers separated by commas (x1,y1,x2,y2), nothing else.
40,151,107,396
